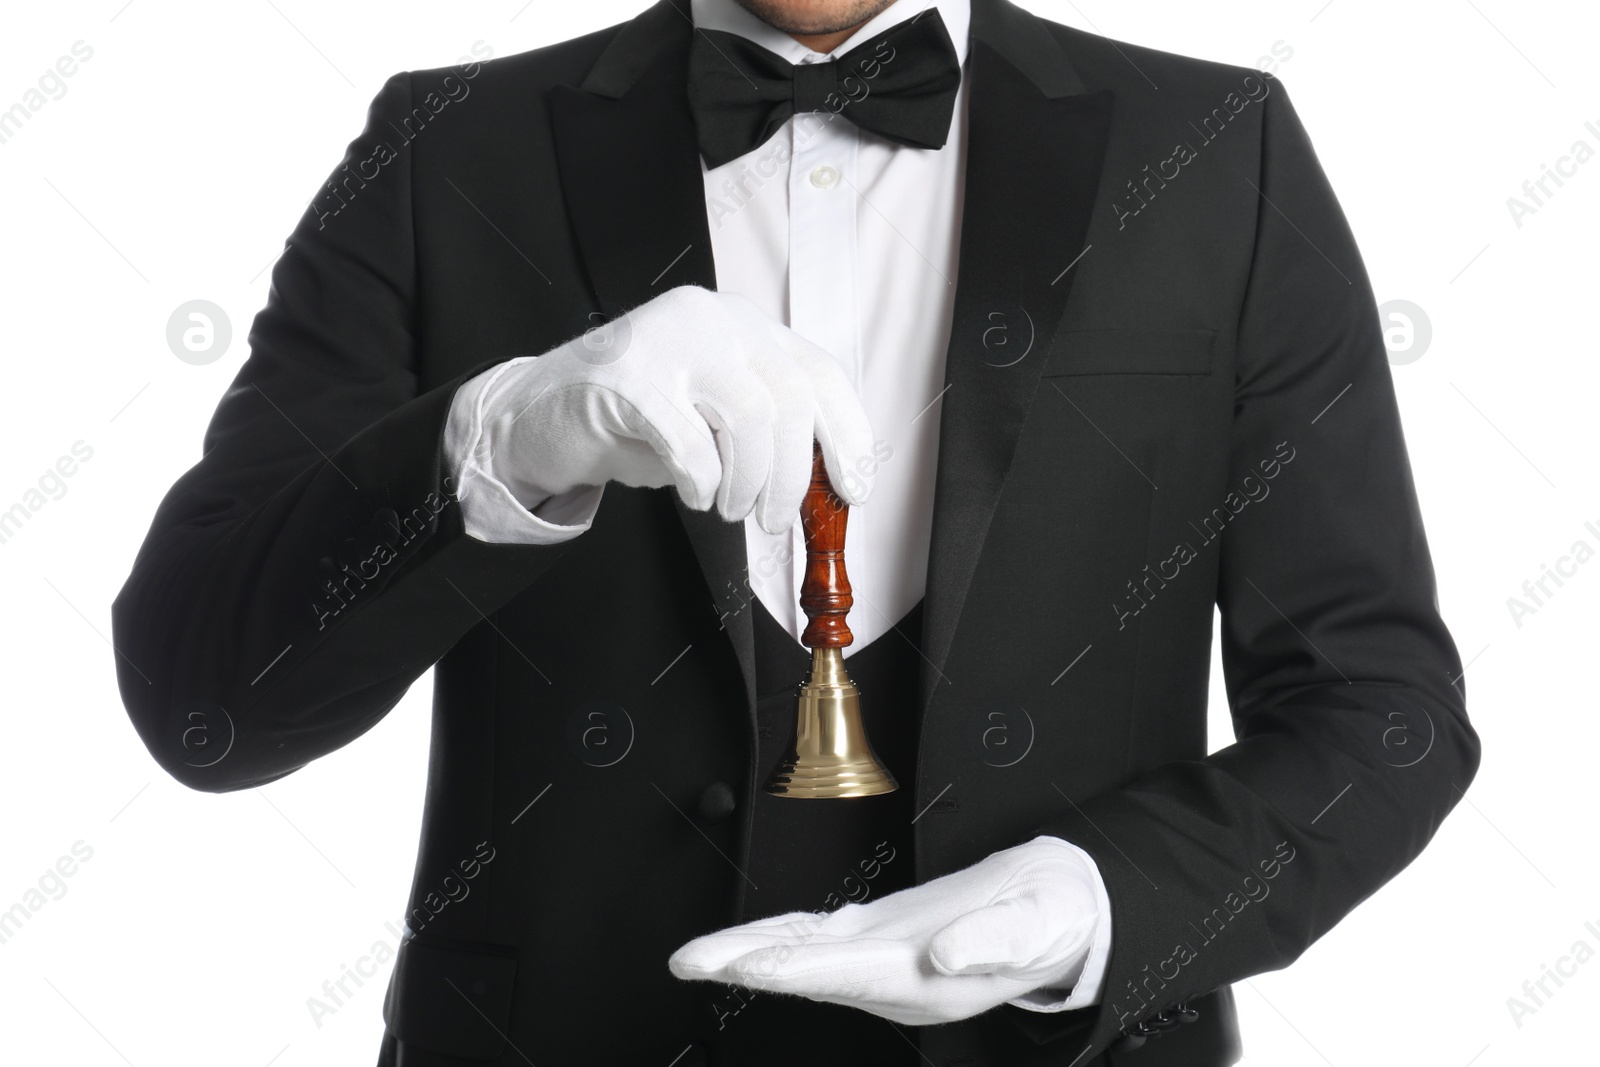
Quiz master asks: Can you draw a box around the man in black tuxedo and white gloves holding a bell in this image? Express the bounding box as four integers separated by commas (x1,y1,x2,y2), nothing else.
115,0,1478,1067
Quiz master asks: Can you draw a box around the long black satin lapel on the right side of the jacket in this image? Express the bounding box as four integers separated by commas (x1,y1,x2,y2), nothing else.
922,0,1112,707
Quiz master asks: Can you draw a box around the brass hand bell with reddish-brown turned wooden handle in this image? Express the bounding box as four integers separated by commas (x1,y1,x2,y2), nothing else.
766,445,899,798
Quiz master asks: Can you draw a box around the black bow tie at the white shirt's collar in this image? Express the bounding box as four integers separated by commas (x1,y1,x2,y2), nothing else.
690,8,962,166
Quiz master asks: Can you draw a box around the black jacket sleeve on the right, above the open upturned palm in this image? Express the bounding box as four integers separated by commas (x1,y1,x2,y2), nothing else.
1045,82,1478,1051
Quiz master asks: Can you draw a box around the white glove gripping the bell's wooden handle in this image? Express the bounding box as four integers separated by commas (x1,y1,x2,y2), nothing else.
445,285,872,544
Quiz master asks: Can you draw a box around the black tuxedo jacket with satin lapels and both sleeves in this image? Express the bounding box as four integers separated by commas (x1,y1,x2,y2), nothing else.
115,0,1478,1067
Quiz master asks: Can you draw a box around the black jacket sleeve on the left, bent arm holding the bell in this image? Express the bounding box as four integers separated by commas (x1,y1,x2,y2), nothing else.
112,74,560,792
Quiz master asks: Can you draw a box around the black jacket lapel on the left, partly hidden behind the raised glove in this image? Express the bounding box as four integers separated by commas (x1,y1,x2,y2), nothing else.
549,0,755,715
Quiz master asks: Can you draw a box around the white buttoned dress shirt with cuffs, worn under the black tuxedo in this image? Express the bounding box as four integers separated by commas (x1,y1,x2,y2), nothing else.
445,0,1110,1011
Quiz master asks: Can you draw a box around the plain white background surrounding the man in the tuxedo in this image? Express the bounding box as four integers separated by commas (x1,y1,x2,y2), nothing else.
0,0,1600,1067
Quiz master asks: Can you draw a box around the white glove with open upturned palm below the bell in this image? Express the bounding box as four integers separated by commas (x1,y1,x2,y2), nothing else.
669,837,1110,1025
